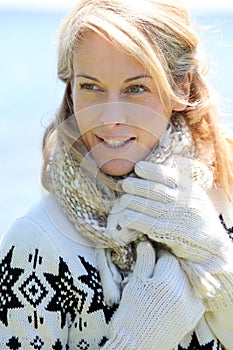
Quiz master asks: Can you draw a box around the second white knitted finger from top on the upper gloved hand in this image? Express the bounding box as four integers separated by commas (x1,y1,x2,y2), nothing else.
121,177,178,203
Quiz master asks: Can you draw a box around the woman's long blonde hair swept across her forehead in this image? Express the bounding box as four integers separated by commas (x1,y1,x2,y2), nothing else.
42,0,233,196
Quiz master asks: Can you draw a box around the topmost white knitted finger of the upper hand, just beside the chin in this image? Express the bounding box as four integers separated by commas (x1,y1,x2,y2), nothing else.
134,161,179,188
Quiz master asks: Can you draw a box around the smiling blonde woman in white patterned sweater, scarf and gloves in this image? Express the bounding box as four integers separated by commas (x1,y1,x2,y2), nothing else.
0,0,233,350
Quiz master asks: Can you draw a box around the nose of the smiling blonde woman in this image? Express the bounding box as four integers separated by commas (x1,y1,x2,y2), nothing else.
100,101,126,128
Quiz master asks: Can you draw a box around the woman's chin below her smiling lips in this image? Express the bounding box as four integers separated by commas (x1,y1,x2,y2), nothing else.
101,159,135,176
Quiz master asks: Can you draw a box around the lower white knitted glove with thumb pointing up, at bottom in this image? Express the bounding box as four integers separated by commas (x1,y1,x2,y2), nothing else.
103,242,205,350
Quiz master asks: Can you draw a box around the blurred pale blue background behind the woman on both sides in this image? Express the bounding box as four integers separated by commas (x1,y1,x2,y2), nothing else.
0,0,233,236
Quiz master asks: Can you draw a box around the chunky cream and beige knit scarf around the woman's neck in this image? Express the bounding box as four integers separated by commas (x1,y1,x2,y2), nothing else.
48,116,222,304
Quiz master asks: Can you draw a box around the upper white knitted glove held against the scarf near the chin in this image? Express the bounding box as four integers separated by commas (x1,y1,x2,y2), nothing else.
110,162,233,311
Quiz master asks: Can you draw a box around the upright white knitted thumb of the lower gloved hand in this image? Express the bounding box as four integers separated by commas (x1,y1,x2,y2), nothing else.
133,241,156,279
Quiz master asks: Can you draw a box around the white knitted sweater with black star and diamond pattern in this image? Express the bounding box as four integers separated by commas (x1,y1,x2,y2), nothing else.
0,195,233,350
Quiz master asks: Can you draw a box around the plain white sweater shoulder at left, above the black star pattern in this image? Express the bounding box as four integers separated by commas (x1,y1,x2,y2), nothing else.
0,195,98,270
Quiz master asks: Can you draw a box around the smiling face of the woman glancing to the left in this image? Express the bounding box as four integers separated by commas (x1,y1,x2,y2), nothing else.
72,31,183,176
